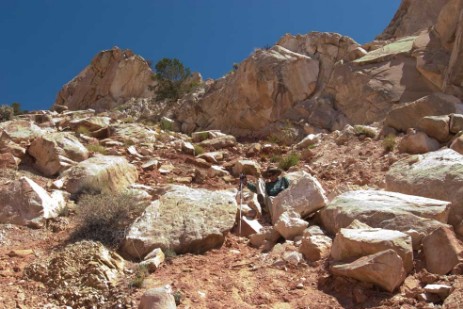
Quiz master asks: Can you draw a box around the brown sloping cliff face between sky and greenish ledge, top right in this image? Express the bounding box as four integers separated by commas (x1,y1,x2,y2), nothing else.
377,0,447,40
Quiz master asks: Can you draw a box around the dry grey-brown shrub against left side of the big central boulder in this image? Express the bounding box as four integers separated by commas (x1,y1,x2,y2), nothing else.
71,193,146,248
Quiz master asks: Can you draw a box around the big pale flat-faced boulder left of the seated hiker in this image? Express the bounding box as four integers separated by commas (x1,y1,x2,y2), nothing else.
122,186,237,258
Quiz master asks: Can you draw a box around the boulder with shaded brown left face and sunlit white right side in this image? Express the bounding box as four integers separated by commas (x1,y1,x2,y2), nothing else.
27,132,89,176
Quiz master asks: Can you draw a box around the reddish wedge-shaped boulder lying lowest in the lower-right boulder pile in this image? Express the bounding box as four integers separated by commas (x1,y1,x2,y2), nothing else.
330,249,406,292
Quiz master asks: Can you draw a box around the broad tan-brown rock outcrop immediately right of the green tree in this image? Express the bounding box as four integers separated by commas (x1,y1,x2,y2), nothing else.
176,45,319,137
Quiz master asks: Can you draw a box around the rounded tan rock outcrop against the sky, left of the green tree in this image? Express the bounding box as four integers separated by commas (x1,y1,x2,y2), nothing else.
54,47,154,112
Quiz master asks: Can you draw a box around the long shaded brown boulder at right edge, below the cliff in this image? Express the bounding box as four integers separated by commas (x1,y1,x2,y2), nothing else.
384,93,463,132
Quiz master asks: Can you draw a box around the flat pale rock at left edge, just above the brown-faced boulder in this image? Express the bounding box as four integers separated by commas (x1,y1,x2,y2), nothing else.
0,120,48,143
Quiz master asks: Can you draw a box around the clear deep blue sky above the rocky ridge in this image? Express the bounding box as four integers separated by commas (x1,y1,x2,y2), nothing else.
0,0,400,110
